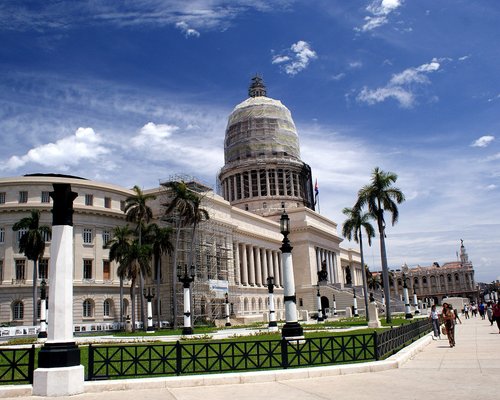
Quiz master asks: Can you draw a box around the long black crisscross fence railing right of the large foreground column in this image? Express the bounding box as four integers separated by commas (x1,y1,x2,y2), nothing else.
87,319,432,380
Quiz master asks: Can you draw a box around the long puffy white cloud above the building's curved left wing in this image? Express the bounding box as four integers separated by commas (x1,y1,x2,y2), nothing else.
2,128,108,170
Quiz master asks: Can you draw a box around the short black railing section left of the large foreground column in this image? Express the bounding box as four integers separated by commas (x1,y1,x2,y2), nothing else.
0,345,35,384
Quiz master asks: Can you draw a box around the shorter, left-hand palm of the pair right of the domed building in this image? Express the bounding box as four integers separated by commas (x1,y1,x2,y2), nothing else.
342,207,375,321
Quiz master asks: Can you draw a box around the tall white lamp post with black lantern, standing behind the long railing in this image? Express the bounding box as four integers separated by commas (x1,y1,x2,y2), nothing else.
280,210,304,338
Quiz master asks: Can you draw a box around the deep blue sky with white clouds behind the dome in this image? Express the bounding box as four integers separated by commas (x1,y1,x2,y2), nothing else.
0,0,500,282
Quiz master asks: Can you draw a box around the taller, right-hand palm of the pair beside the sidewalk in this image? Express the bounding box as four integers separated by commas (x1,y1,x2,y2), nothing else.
356,167,405,323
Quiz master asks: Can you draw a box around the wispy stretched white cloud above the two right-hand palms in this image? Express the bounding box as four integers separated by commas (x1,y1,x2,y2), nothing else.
357,59,440,108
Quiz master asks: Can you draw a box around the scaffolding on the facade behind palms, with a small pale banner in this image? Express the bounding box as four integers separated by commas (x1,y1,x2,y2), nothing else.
160,174,235,326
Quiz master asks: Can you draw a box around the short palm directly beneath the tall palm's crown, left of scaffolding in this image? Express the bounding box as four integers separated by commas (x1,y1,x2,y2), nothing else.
117,240,152,332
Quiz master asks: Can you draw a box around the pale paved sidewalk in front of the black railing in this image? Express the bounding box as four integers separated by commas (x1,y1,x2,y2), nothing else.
0,317,500,400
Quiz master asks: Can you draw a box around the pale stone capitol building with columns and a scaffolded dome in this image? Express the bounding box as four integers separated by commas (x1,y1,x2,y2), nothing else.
0,77,472,328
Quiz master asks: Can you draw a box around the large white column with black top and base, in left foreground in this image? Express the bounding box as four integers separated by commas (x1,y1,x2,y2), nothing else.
33,183,84,396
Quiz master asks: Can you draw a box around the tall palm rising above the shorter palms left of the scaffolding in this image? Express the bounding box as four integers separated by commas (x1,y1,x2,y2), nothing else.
123,185,156,326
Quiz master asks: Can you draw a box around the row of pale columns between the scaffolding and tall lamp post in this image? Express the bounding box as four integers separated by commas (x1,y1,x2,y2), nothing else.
233,242,283,287
